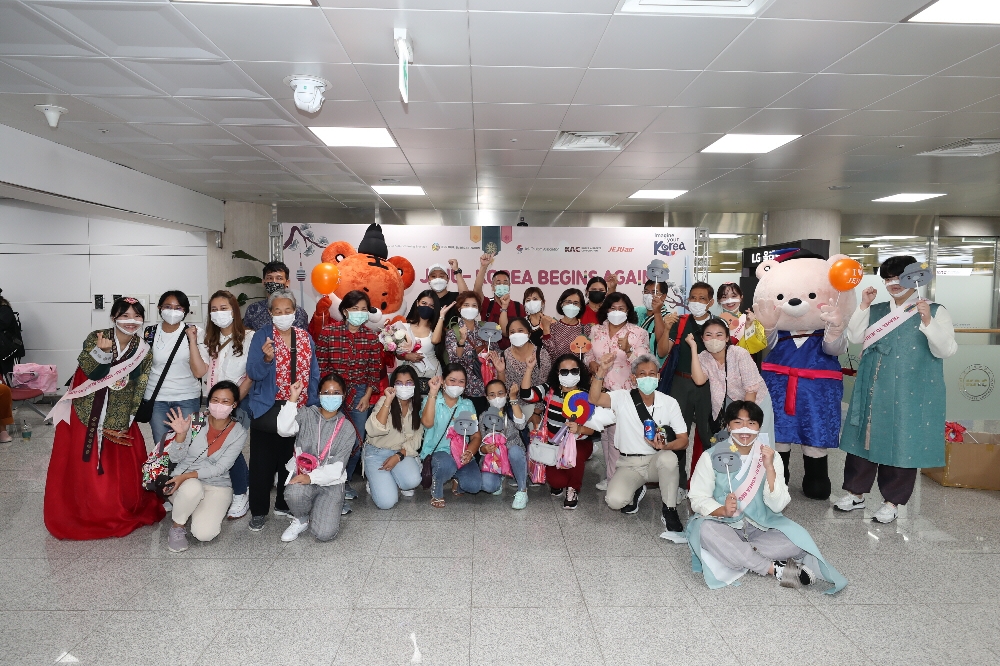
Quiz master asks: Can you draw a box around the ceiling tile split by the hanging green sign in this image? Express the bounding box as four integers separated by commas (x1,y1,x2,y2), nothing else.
356,64,472,102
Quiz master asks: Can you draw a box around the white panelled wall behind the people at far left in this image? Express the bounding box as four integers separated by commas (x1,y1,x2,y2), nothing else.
0,199,211,382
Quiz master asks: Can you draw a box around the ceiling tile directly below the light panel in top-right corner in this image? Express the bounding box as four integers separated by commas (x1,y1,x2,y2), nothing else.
829,23,997,75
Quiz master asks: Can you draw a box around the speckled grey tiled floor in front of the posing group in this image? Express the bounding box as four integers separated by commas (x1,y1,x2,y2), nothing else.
0,415,1000,666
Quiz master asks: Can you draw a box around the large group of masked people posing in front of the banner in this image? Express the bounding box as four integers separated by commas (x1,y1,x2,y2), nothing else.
29,248,950,592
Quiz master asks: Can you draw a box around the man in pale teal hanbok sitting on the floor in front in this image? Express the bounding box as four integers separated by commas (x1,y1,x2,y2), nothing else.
687,400,847,594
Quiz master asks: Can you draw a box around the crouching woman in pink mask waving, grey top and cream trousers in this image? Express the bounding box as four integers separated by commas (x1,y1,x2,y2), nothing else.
163,381,247,553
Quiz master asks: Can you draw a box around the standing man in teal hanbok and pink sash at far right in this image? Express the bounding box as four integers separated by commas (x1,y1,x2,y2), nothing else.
834,256,958,523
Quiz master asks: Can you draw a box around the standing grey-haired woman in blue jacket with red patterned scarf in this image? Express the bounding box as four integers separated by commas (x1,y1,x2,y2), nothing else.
246,289,319,532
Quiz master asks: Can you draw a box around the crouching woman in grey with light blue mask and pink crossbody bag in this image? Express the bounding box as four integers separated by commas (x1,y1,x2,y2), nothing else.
278,372,358,541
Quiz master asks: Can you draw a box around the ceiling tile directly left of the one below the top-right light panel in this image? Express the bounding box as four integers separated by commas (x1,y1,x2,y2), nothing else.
710,19,889,72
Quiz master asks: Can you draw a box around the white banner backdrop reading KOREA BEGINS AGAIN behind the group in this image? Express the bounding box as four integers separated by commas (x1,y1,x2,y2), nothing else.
281,224,694,316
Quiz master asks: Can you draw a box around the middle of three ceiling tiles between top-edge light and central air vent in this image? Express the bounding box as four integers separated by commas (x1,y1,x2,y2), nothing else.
573,69,698,106
